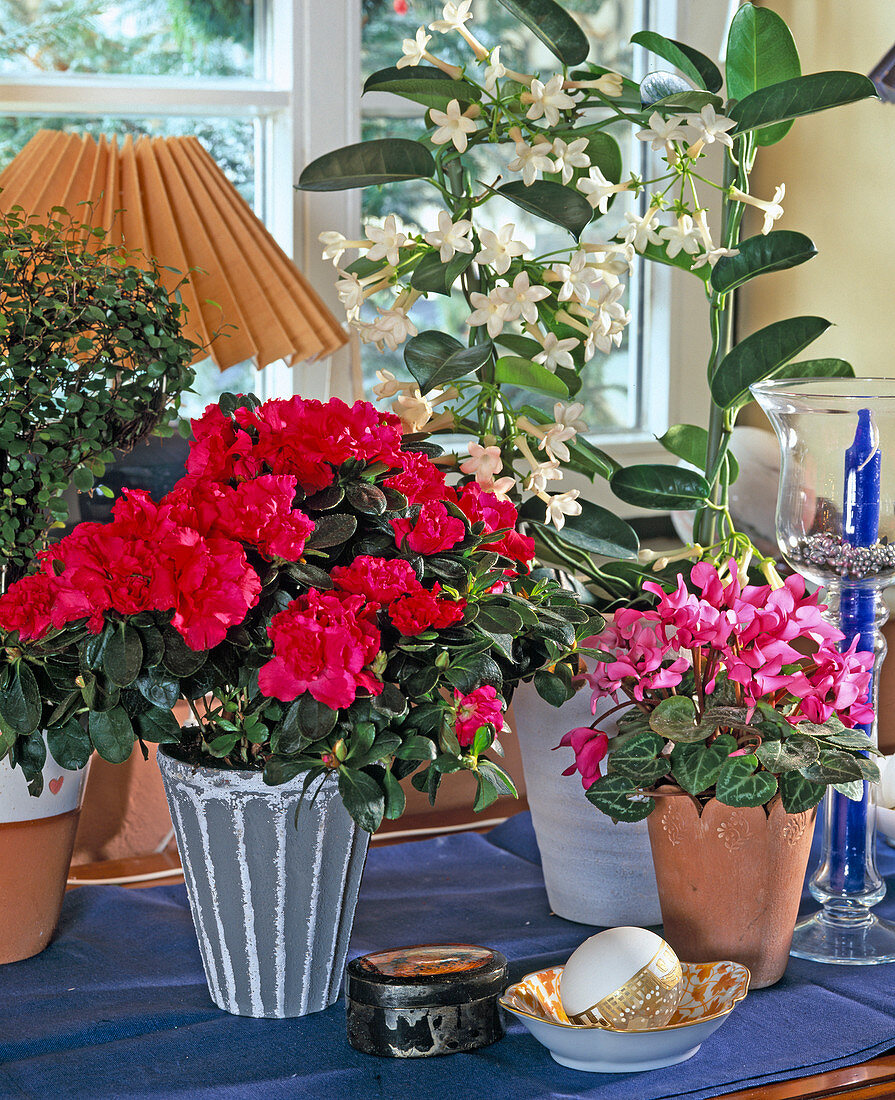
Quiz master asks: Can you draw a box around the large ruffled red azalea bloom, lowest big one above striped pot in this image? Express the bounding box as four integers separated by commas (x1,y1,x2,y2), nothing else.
258,589,383,710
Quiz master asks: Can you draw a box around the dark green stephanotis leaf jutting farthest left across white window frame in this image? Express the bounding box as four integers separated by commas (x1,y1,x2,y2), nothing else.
297,138,435,191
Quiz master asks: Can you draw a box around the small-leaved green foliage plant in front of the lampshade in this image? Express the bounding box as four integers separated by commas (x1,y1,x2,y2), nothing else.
0,208,198,591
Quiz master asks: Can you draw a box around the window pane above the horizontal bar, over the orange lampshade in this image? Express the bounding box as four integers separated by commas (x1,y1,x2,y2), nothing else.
0,0,255,77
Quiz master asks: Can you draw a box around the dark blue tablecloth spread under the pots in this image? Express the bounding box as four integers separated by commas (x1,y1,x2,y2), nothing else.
0,814,895,1100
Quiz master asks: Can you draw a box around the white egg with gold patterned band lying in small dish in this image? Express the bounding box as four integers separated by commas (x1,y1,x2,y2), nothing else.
560,927,682,1031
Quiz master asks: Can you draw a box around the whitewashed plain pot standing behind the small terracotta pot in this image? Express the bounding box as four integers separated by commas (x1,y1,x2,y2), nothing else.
512,684,662,927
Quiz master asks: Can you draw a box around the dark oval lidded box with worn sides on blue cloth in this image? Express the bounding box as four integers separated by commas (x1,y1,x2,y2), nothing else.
346,944,507,1058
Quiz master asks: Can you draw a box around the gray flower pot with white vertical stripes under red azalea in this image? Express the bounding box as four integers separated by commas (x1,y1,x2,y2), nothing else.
158,748,369,1018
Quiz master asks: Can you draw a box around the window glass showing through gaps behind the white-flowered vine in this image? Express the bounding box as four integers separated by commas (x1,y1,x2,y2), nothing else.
362,0,643,433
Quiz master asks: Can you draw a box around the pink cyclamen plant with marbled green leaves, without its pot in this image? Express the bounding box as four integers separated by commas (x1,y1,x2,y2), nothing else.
557,562,880,821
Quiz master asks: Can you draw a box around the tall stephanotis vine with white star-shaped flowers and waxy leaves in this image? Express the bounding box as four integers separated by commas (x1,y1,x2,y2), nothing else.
298,0,876,607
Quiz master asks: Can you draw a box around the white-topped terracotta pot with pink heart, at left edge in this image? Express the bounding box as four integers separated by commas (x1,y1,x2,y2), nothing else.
0,754,88,963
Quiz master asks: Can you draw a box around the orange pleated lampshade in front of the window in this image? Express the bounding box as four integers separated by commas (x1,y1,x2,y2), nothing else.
0,130,346,371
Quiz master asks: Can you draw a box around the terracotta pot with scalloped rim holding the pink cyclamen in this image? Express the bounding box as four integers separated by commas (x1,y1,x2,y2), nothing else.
648,796,815,989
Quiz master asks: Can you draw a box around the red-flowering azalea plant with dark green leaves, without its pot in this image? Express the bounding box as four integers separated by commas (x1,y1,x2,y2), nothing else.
0,396,601,831
